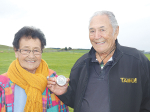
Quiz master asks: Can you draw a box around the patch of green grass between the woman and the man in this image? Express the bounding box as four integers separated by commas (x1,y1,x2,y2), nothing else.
42,52,83,77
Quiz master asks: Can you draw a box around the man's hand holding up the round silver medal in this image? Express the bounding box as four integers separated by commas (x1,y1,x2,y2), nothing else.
47,77,70,95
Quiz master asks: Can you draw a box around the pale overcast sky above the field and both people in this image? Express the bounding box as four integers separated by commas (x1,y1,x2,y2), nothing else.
0,0,150,51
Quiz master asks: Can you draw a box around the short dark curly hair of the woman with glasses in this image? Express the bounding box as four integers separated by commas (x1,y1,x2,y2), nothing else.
13,26,46,50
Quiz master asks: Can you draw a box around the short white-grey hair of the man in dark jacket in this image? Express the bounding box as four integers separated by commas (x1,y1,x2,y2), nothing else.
89,11,118,33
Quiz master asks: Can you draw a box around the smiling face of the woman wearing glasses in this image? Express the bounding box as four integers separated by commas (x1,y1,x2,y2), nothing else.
15,37,42,73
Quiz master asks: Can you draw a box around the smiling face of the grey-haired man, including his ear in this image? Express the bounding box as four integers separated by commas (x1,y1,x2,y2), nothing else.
89,15,119,54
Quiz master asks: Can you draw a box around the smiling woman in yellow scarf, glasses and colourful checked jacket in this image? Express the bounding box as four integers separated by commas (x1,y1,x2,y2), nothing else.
0,27,68,112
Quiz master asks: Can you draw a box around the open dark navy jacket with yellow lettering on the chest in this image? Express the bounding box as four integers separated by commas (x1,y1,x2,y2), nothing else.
58,41,150,112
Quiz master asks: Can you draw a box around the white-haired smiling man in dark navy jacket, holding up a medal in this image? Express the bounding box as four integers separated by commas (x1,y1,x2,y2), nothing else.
48,11,150,112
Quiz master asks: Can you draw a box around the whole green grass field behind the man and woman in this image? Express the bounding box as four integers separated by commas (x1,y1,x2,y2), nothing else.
0,50,150,112
